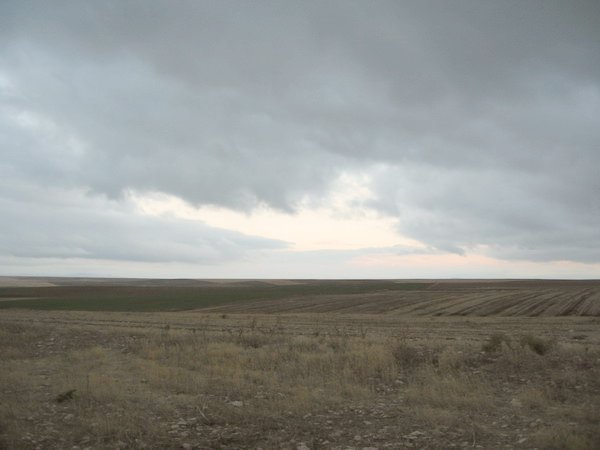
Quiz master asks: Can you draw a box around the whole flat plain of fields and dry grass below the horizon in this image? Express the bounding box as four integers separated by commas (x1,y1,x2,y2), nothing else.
0,278,600,450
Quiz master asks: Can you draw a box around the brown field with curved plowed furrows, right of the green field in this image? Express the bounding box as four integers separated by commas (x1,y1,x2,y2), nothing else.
199,280,600,317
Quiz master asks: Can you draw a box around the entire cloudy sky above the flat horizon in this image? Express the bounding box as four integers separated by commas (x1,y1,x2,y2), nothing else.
0,0,600,278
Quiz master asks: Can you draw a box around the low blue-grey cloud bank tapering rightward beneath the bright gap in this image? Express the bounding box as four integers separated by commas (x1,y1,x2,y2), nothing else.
0,175,286,264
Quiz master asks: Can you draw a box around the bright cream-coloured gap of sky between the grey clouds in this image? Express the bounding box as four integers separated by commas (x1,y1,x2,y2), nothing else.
131,174,422,251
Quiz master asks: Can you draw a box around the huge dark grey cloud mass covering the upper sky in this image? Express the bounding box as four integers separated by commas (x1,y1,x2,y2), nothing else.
0,1,600,262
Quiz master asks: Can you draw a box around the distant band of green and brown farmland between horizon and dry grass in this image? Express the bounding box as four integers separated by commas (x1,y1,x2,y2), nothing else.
0,279,600,317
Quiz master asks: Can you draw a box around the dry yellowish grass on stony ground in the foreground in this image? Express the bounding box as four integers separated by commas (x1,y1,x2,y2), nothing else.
0,312,600,449
